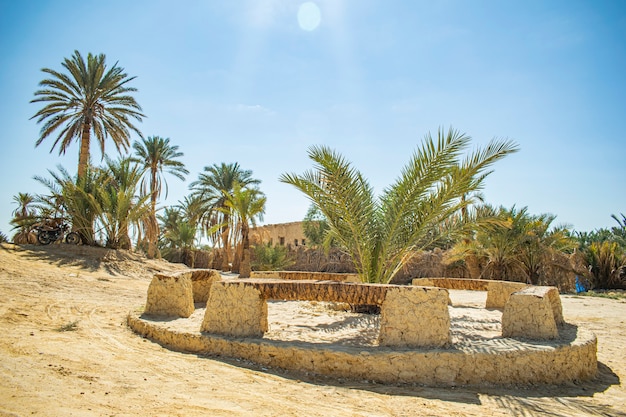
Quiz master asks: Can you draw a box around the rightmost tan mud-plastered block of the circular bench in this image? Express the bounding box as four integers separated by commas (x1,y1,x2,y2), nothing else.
502,287,563,340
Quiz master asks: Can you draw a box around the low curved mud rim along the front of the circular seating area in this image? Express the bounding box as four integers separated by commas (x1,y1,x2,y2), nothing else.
127,315,597,386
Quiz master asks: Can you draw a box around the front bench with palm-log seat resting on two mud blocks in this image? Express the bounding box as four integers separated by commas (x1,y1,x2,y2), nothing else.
201,279,450,347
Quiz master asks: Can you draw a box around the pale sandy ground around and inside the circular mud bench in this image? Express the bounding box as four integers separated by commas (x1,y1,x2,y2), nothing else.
0,245,626,417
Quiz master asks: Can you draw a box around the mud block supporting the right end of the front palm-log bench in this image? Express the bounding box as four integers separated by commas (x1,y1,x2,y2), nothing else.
378,286,450,347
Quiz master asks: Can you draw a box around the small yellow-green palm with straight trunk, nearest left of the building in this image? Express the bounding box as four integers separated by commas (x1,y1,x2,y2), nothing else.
225,183,267,278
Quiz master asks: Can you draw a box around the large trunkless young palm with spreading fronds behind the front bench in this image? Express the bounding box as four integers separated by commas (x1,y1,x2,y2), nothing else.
280,130,517,283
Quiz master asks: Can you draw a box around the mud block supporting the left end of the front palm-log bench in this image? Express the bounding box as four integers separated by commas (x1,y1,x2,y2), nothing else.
201,281,268,337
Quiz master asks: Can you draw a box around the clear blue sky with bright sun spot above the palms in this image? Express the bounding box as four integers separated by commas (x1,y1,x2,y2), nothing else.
0,0,626,236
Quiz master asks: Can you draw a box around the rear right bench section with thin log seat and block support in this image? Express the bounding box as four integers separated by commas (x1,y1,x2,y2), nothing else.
412,278,529,310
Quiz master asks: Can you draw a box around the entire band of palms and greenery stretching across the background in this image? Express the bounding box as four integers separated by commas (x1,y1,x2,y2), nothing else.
0,51,626,291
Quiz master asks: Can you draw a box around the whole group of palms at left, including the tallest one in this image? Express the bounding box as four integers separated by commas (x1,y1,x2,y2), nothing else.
21,51,265,274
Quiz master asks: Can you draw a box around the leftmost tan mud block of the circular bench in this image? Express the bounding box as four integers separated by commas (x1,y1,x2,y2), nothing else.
144,272,194,317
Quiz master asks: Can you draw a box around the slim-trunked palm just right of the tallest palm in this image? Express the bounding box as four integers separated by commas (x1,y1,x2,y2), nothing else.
133,136,189,258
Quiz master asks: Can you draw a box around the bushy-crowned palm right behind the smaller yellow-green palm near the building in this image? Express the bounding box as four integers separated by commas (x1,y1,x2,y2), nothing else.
190,162,261,271
